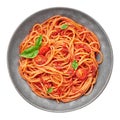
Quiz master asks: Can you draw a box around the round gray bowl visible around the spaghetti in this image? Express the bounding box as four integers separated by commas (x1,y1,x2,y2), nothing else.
7,8,113,112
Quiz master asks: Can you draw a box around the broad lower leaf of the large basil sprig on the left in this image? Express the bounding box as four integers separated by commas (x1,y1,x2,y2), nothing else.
20,49,39,58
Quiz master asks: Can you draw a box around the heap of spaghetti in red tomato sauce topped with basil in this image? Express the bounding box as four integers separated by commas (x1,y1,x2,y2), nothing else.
18,15,103,102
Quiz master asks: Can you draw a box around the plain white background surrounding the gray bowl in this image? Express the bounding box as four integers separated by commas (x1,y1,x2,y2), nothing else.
0,0,120,120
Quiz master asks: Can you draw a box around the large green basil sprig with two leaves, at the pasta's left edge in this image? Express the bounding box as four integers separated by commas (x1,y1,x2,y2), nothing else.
20,35,42,58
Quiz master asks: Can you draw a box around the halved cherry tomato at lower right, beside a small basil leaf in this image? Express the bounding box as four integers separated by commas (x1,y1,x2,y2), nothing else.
76,68,87,80
